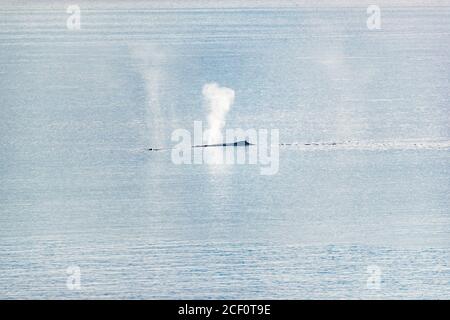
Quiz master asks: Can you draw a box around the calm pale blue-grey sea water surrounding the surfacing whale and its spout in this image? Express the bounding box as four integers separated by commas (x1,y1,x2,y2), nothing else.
0,2,450,299
